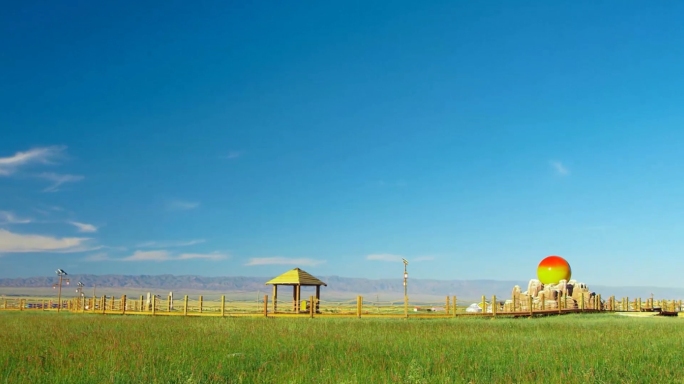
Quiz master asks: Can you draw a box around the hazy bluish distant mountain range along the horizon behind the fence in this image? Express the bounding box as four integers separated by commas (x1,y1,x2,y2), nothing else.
0,275,684,300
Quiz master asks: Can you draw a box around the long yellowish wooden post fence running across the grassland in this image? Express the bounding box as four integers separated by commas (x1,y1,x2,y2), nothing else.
0,295,683,318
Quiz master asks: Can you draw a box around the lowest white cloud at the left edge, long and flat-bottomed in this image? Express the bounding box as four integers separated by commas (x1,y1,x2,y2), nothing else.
0,229,94,253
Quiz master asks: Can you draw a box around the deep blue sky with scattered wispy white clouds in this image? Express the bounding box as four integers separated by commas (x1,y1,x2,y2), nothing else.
0,1,684,287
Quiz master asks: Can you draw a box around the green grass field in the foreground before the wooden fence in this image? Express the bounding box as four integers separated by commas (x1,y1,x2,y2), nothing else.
0,312,684,384
